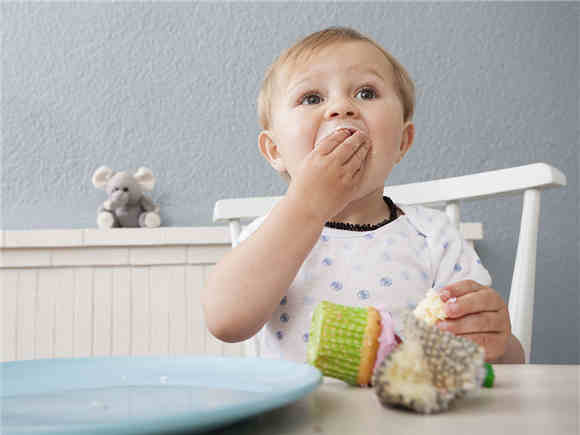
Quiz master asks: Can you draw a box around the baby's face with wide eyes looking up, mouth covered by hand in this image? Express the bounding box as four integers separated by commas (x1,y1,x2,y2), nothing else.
260,41,413,197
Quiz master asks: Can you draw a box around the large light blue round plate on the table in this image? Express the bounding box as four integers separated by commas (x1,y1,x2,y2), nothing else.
0,356,322,435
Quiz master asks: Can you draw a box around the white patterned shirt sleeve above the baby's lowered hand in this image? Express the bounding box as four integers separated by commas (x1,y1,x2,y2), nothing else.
414,208,492,288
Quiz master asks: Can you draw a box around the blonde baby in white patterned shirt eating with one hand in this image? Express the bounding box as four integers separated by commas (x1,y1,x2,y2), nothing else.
202,28,523,362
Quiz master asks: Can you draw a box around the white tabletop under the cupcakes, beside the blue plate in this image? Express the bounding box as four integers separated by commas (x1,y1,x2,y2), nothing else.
211,365,580,435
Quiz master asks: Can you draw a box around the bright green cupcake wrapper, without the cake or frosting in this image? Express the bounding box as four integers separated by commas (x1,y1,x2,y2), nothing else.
307,301,368,385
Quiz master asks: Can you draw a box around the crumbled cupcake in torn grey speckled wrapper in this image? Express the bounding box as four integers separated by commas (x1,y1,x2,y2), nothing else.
373,290,494,414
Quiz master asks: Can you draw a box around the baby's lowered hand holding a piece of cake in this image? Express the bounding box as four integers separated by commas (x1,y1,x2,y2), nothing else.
437,280,511,361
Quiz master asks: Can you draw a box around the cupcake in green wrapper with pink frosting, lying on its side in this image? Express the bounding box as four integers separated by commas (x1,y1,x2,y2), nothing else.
307,301,401,386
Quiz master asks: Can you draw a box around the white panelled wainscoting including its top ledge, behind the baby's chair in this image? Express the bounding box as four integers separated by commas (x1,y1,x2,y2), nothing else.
0,223,483,361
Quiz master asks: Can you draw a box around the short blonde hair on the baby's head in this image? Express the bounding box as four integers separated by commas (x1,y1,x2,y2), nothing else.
258,27,415,130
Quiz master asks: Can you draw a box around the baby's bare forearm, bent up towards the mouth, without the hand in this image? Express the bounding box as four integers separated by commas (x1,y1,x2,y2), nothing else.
202,196,324,342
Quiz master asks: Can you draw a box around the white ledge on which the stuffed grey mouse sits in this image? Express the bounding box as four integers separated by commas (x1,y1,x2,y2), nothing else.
0,226,230,249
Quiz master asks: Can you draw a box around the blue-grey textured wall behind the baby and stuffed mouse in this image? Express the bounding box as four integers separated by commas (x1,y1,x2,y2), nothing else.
0,2,580,363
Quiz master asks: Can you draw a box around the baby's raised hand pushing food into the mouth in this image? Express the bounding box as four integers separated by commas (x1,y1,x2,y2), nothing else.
288,129,371,221
